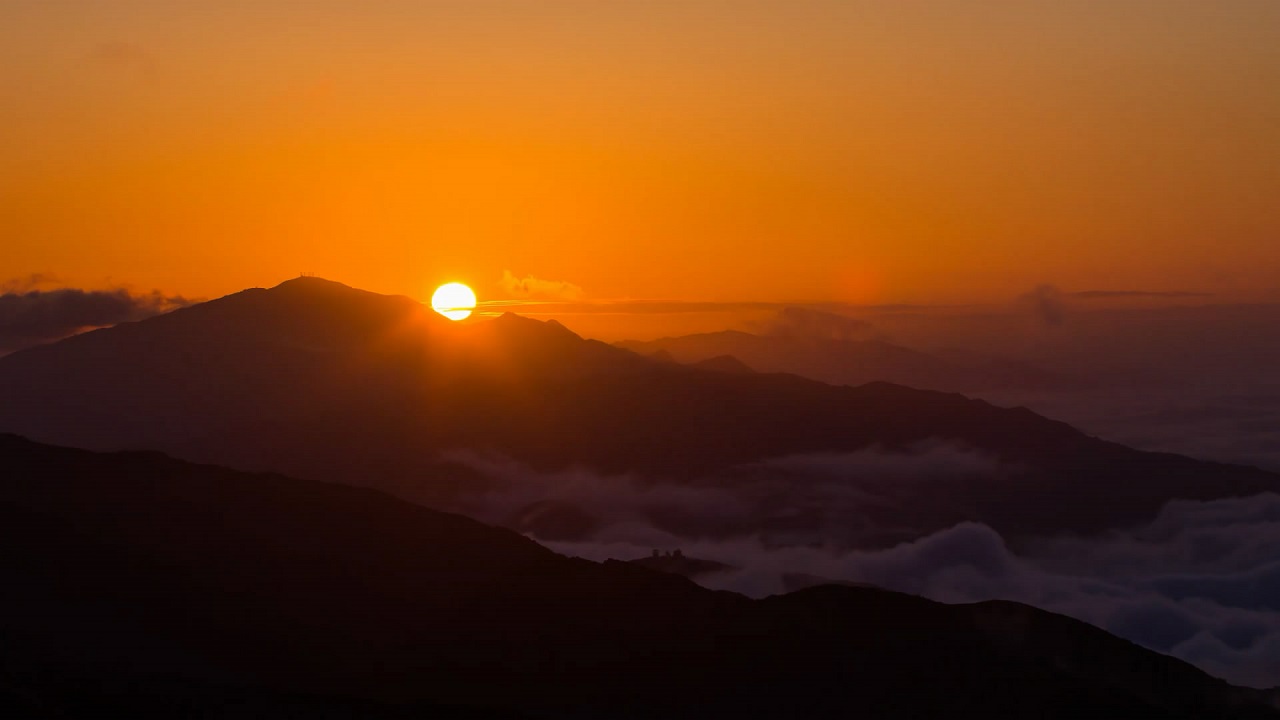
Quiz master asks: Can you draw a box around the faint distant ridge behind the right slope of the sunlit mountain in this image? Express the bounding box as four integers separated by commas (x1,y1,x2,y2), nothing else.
616,324,1073,395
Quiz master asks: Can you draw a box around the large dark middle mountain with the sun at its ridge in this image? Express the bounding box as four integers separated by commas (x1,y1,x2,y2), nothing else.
0,278,1280,544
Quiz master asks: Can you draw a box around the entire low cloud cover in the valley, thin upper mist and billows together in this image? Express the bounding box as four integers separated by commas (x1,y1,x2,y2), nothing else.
442,443,1280,687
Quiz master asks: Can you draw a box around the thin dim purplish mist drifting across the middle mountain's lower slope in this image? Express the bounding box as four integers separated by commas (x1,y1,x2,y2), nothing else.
440,442,1011,548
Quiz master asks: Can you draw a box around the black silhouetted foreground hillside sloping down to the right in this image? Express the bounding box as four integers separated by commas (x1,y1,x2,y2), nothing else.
0,436,1280,720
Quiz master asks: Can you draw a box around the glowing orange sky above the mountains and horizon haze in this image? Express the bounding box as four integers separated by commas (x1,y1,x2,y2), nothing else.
0,0,1280,312
